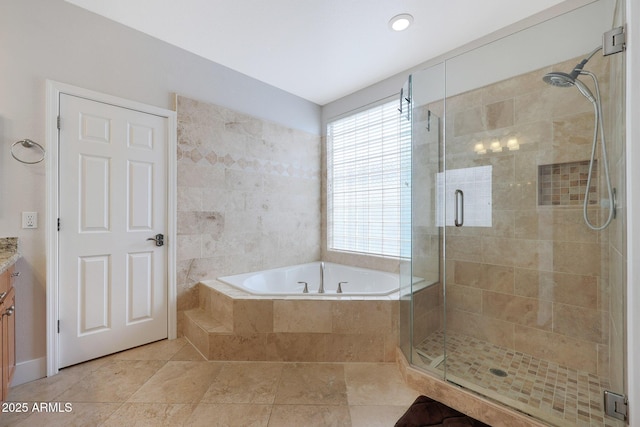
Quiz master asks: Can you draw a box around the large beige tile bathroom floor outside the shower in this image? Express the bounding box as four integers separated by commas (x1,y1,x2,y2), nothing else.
0,339,420,427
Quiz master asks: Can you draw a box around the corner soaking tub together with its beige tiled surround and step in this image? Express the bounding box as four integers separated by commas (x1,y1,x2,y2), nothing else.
190,262,430,363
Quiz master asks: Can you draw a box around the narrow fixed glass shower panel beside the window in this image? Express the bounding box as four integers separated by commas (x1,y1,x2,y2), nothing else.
400,63,445,377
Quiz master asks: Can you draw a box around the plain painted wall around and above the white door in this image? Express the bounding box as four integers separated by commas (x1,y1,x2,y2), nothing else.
0,0,321,384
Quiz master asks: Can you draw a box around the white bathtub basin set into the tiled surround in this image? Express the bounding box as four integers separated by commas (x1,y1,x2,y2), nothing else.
218,262,399,297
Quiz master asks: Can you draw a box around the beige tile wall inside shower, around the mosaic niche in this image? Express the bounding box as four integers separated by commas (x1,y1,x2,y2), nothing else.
446,55,624,376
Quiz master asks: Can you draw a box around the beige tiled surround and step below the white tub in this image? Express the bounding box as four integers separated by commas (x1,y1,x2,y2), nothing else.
183,280,399,362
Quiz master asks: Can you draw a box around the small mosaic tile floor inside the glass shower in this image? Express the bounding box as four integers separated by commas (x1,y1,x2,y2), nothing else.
414,332,625,427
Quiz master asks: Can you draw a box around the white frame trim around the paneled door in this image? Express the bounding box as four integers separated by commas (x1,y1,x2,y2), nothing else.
45,80,177,376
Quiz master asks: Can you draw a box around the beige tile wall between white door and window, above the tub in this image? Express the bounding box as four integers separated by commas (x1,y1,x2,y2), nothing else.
177,96,320,310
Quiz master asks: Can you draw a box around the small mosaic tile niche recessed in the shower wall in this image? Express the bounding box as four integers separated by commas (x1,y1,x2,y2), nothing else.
538,160,598,206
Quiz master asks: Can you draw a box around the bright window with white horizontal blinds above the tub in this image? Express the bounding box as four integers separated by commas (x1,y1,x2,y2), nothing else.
327,100,410,257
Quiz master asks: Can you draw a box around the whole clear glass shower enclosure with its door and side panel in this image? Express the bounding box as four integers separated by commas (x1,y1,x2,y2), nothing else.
400,0,626,426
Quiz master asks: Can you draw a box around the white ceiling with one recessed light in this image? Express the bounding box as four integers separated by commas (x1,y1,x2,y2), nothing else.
67,0,563,105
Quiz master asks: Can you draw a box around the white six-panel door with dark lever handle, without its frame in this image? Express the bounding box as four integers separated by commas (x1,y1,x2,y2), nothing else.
58,94,168,368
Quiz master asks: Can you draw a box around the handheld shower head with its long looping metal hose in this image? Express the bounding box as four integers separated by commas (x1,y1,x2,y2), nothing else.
542,46,616,231
